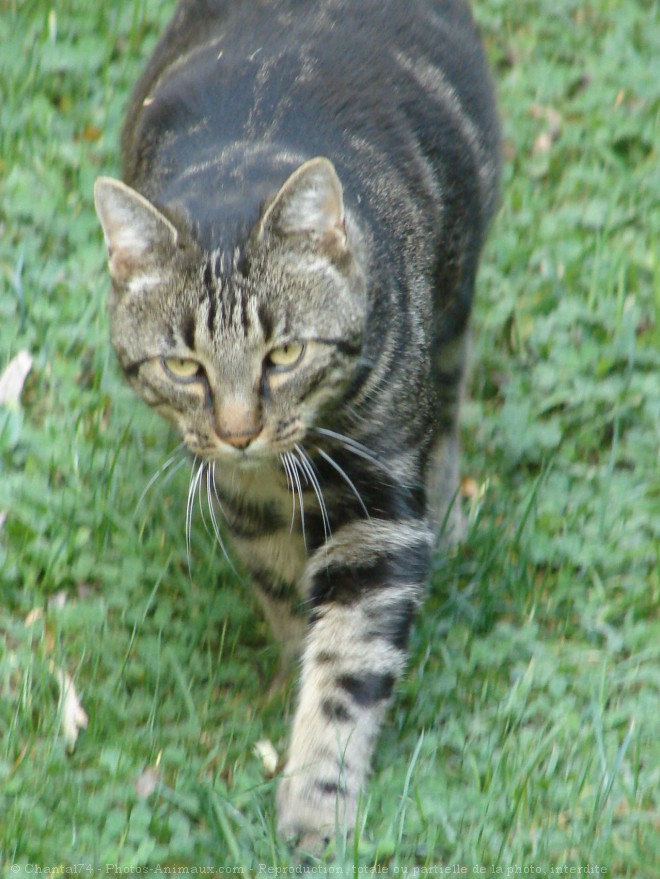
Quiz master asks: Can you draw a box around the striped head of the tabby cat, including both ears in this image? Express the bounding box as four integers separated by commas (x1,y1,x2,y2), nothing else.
95,158,366,462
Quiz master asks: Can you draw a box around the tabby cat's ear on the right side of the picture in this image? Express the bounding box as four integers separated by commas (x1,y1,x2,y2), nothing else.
257,157,346,250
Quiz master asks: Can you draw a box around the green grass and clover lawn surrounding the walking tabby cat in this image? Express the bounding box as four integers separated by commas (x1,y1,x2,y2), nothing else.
0,0,660,879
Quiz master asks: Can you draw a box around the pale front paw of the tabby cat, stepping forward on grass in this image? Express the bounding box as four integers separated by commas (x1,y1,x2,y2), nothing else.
277,770,355,855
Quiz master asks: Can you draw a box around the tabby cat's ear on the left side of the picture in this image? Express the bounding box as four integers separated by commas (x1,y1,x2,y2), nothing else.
94,177,178,286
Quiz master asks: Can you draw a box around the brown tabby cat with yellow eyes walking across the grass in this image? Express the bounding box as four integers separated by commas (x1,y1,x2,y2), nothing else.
95,0,500,850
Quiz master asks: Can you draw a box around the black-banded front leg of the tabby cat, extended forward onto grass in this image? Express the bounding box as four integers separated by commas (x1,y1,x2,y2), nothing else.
278,520,432,850
